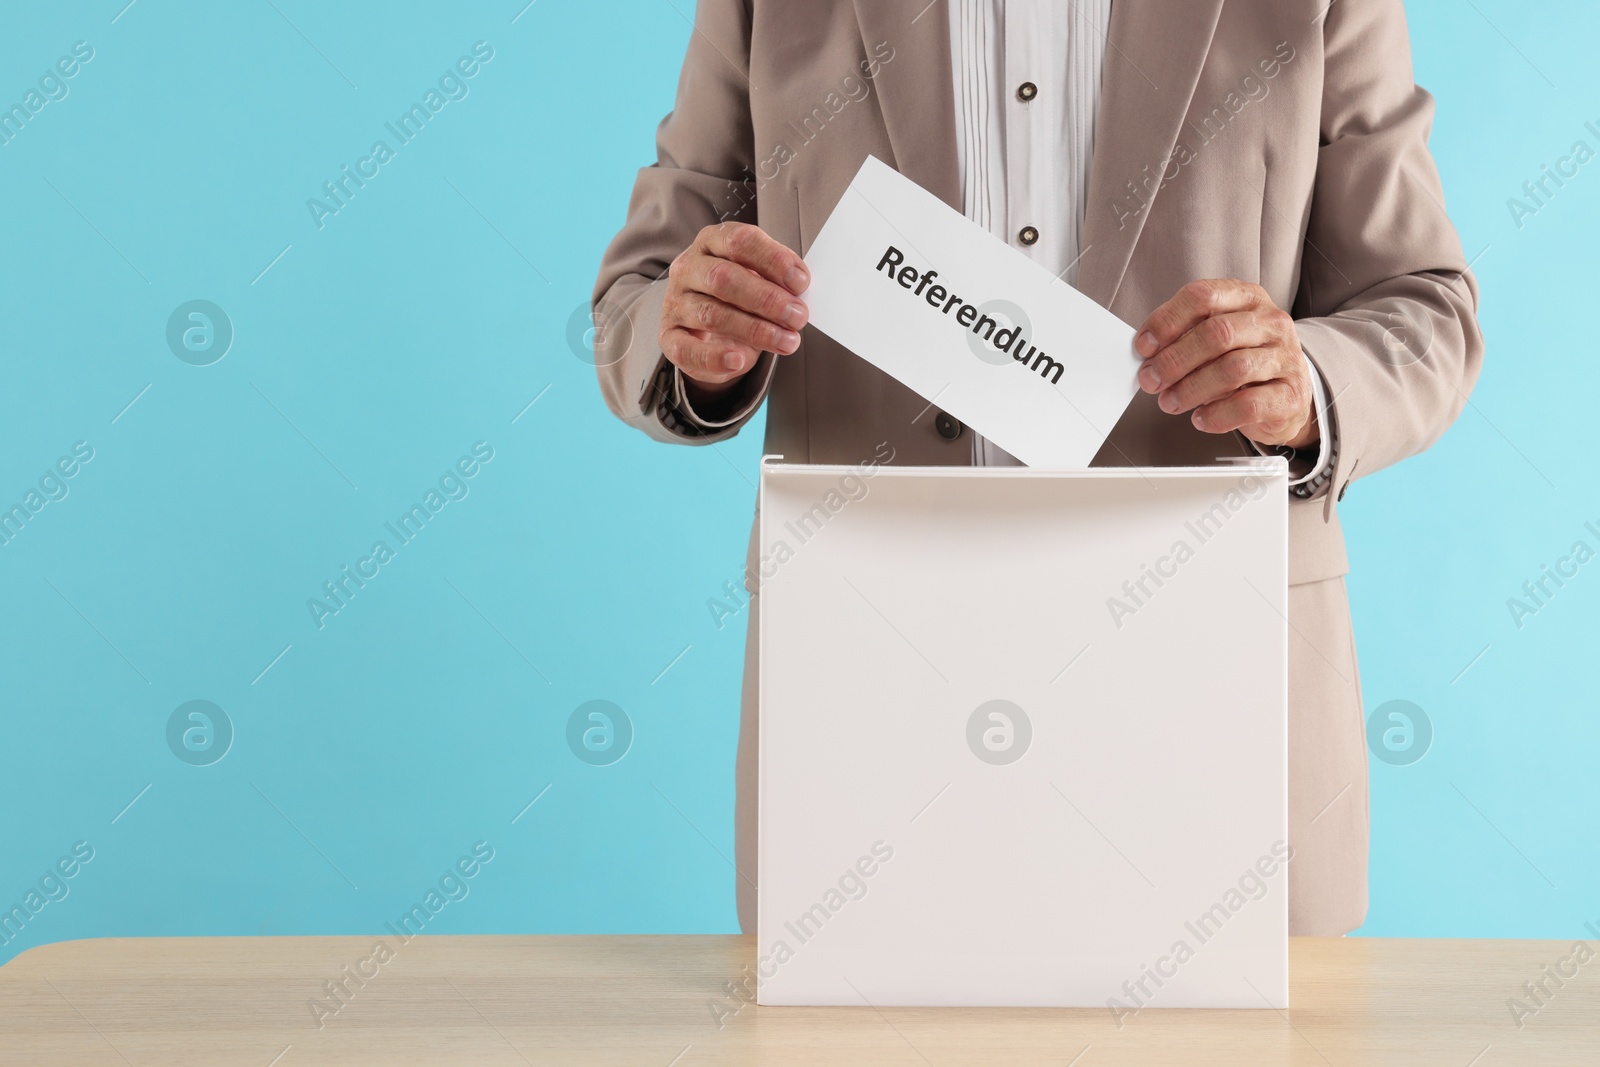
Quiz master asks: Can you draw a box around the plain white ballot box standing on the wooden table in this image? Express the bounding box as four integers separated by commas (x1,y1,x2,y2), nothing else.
757,458,1290,1019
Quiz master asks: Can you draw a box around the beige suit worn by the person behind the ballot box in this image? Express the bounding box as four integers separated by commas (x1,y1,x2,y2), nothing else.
595,0,1483,934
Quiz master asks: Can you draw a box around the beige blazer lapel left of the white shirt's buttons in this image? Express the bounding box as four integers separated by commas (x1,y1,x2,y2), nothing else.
854,0,962,211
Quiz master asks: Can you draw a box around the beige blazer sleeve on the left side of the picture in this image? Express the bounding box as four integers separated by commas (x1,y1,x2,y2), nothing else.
592,0,776,445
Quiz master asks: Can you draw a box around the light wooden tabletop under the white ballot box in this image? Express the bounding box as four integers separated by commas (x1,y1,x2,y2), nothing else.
0,936,1600,1067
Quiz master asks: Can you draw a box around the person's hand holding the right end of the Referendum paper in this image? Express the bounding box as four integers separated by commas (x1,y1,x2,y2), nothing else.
1133,278,1318,448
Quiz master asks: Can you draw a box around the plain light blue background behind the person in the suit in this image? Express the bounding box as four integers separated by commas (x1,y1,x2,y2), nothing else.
0,0,1600,958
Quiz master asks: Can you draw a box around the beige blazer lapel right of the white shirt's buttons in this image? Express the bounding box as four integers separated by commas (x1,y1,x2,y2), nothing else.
1081,0,1222,307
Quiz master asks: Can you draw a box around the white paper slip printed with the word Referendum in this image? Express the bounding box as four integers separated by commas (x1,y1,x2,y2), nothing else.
802,155,1139,467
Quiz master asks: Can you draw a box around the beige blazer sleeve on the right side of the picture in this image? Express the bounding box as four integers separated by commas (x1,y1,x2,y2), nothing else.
1294,0,1483,517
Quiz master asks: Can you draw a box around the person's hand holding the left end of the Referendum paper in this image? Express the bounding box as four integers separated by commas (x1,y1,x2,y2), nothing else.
661,222,811,397
